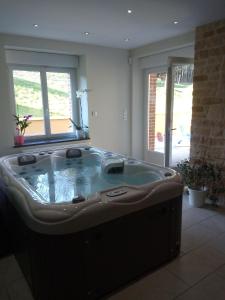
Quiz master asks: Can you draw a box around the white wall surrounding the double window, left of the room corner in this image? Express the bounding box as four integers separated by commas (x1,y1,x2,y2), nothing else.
0,34,130,155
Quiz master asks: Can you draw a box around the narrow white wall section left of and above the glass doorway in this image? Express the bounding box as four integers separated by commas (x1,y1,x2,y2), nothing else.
130,32,194,159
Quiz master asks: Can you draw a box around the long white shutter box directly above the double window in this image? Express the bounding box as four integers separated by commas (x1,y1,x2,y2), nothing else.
6,50,79,68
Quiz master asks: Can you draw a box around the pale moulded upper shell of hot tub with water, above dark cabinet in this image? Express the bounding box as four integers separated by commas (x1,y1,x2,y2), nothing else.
0,146,182,233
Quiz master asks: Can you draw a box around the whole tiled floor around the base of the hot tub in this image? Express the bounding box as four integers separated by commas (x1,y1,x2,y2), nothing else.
0,196,225,300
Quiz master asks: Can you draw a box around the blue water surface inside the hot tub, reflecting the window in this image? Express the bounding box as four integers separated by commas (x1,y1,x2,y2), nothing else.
14,156,160,203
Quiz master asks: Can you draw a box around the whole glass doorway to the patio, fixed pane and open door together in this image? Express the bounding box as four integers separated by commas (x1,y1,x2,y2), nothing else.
144,58,194,167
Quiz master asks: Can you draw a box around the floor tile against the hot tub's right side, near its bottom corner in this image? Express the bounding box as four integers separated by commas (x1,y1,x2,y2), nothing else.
181,224,215,253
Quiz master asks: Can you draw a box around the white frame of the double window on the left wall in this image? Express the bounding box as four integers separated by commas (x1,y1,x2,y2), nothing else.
9,64,80,144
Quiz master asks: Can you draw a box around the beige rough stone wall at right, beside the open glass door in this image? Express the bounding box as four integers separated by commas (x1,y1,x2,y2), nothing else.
191,20,225,165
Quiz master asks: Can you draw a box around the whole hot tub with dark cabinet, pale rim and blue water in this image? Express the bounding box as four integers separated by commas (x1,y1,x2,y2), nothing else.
0,145,183,300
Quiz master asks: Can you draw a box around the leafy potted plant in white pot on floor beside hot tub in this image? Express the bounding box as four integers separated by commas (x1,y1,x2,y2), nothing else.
177,159,212,207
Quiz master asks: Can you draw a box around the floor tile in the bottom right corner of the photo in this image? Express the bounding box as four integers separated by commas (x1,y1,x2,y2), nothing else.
176,274,225,300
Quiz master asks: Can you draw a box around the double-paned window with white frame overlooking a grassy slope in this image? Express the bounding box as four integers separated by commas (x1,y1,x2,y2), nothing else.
11,66,79,140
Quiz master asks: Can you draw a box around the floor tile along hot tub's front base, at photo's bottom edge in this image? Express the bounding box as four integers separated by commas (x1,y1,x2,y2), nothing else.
109,268,188,300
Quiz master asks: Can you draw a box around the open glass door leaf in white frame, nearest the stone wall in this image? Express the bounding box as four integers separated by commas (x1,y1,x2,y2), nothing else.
165,58,194,167
